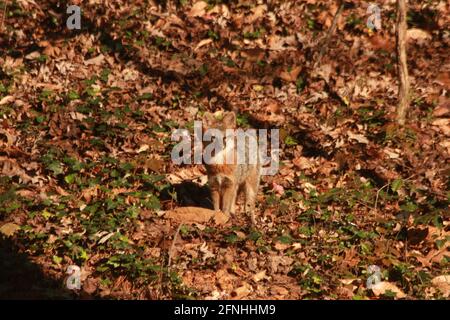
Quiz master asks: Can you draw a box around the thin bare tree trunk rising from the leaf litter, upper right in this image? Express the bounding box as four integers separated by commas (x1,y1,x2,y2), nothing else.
397,0,409,125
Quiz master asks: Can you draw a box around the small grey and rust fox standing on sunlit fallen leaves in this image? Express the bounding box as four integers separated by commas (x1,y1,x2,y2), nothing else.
202,111,261,225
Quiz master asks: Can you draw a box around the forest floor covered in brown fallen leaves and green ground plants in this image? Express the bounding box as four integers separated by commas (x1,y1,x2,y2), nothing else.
0,0,450,299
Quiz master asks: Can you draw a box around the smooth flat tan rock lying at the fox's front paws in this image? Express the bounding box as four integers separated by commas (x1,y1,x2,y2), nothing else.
165,207,229,225
